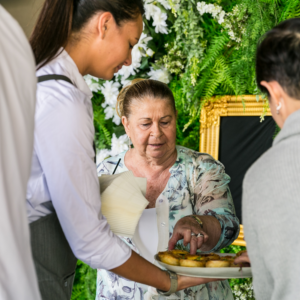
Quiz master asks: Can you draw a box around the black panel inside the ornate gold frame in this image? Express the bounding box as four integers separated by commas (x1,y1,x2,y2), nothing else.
219,117,275,223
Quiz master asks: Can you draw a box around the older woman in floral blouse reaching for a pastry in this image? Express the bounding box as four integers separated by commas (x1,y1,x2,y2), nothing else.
96,80,239,300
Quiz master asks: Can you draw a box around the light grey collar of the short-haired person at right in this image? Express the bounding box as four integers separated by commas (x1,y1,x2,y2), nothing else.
273,109,300,146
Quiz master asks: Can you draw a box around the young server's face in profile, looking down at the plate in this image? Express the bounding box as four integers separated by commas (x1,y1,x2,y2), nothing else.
90,15,143,80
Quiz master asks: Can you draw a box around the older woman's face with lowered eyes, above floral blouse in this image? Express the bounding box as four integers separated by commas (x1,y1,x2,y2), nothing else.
122,98,177,159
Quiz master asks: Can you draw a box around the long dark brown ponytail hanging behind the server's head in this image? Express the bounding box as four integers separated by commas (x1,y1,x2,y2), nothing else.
29,0,74,68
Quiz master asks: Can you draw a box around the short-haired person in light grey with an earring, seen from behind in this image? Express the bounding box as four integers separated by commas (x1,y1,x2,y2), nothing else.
236,19,300,300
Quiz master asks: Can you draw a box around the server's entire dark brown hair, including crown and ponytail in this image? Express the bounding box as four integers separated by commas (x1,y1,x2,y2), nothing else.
30,0,144,68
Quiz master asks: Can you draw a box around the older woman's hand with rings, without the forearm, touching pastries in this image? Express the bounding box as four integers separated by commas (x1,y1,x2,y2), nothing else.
169,216,209,254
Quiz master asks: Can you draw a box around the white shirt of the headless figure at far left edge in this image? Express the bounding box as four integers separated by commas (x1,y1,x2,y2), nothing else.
0,5,41,300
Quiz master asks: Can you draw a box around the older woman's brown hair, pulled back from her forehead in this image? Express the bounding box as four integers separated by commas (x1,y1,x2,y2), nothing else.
116,78,176,118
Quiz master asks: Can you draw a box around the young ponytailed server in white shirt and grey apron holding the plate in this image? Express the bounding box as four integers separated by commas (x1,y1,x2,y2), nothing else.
27,0,218,300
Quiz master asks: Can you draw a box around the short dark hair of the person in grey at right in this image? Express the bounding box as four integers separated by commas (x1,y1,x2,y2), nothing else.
256,18,300,99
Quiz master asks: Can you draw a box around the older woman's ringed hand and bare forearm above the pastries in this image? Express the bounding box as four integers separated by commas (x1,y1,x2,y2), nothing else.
169,216,221,254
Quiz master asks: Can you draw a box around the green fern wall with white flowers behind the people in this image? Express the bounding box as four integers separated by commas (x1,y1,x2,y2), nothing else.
72,0,300,300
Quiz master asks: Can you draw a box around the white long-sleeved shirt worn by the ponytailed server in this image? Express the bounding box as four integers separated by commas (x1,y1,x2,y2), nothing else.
26,51,131,270
